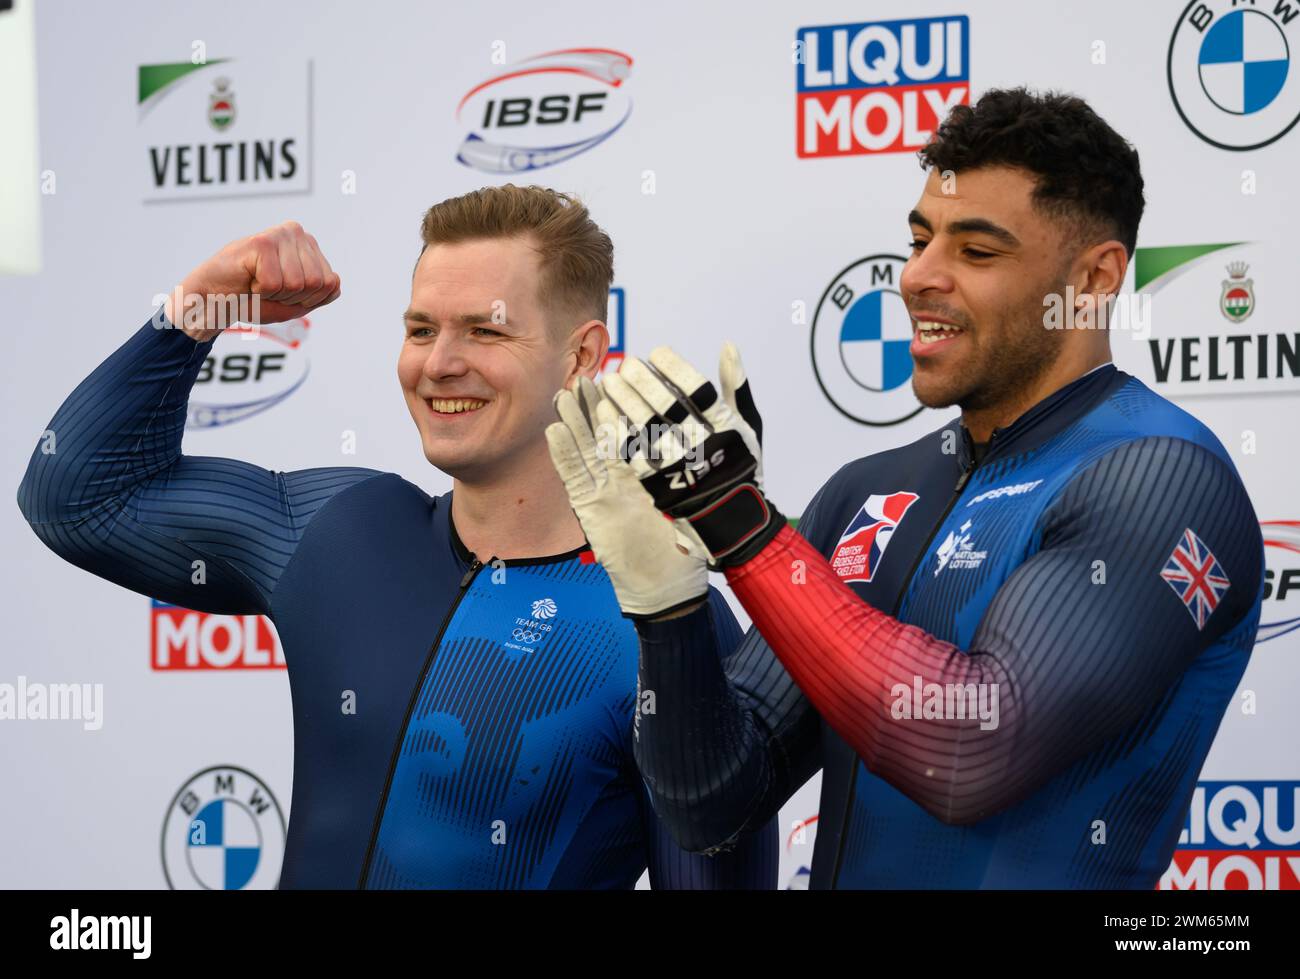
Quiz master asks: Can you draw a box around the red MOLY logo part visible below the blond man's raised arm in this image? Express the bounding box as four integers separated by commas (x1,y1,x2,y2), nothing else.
150,599,285,670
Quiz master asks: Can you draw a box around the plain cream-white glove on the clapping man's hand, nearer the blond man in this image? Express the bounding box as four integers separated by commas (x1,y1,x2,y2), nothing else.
546,377,709,619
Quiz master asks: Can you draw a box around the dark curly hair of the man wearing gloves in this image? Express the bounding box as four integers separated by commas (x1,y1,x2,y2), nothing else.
918,88,1144,259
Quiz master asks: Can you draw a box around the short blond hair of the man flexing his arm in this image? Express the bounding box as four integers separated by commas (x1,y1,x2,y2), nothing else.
416,183,614,325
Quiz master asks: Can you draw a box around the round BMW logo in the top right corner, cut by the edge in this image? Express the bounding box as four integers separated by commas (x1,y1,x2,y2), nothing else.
1167,0,1300,150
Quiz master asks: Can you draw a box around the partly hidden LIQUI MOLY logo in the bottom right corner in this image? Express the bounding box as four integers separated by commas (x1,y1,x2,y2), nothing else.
1160,781,1300,891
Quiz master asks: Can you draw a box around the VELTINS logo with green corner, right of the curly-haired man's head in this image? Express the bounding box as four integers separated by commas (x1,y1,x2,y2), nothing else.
1113,242,1300,397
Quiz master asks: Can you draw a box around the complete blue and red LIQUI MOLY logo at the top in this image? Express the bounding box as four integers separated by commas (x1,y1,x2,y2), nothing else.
794,17,970,156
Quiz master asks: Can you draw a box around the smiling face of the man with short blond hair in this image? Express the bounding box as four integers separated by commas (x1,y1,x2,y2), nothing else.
398,238,590,482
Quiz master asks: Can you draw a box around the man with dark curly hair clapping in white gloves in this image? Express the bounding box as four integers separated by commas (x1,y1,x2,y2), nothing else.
547,90,1264,889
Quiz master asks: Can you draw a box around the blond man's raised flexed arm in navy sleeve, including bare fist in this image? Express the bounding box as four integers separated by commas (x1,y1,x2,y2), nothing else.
18,225,377,612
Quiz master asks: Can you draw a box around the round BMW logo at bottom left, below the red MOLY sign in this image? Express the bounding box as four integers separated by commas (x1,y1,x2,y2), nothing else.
163,764,286,891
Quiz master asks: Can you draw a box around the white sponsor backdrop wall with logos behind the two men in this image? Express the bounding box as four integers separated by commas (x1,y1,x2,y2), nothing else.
0,0,1300,888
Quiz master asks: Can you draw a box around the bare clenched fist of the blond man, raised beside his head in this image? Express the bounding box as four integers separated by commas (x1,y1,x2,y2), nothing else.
165,221,341,341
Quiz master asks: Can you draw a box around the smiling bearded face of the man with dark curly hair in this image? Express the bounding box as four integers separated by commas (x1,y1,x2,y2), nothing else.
900,166,1086,411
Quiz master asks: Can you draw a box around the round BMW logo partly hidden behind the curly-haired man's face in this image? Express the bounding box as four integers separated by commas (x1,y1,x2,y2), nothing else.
811,255,923,425
